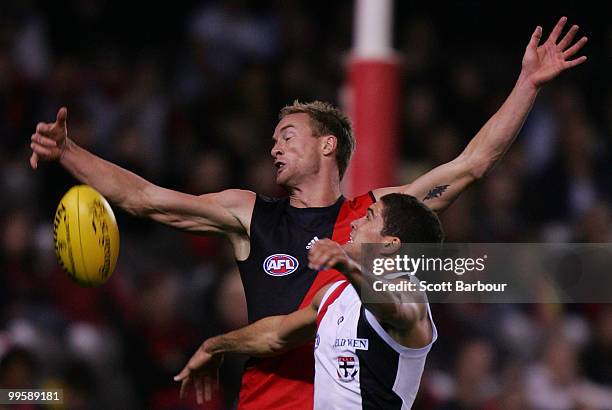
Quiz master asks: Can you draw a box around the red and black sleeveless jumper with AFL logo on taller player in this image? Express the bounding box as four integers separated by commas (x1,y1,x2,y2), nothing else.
238,192,375,410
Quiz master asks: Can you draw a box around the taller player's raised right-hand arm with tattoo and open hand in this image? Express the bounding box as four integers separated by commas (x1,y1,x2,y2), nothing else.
374,17,587,212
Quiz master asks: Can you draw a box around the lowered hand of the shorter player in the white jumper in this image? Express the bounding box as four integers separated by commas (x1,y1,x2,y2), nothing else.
174,345,223,404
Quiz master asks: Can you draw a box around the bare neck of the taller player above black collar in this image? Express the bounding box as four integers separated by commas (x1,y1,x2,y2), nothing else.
289,177,341,208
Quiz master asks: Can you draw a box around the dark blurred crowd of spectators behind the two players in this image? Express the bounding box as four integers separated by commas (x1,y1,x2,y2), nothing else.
0,0,612,410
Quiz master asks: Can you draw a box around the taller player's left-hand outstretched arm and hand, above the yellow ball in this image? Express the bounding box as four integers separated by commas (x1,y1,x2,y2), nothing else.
30,107,255,253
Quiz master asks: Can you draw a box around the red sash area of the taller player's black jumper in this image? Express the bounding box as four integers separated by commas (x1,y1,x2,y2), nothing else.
238,192,375,410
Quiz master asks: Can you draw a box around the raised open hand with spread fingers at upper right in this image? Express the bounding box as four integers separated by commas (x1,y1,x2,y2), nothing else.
521,17,587,87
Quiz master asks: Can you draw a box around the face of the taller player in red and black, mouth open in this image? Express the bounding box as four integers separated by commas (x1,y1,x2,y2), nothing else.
270,113,321,186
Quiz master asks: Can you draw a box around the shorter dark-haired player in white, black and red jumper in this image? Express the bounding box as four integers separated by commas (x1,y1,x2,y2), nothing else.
175,193,443,409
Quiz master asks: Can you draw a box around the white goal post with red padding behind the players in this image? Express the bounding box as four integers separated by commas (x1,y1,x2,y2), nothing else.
344,0,401,196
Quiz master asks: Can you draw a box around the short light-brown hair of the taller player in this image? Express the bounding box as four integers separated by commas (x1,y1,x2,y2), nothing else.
278,100,355,180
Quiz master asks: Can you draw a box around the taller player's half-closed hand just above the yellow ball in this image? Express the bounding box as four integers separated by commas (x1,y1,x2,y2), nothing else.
30,107,68,169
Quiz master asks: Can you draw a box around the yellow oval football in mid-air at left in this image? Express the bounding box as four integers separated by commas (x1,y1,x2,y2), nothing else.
53,185,119,287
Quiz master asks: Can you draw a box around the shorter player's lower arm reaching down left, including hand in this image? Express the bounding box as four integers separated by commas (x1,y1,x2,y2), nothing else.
174,286,329,404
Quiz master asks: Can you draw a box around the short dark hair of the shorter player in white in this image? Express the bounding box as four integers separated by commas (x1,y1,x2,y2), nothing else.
380,193,444,243
